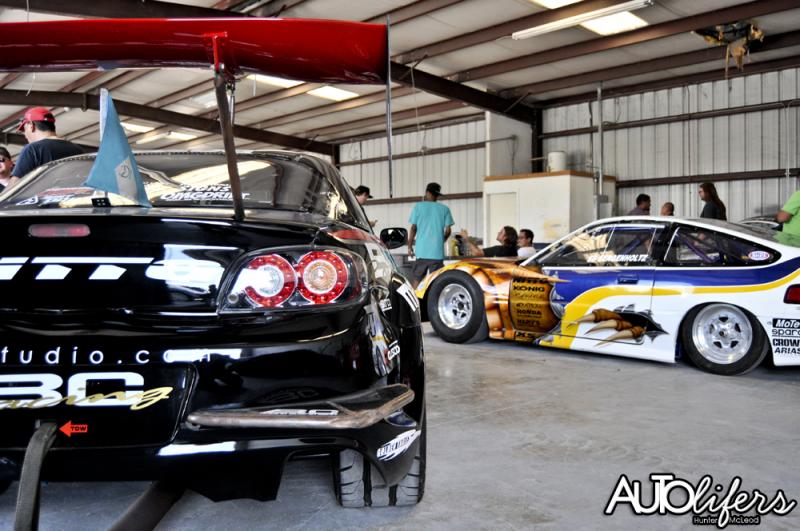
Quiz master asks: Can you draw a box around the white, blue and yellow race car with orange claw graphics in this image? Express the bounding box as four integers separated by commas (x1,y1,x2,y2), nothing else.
417,216,800,375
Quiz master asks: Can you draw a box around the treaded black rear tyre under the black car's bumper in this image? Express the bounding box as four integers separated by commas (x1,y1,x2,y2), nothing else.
333,414,426,507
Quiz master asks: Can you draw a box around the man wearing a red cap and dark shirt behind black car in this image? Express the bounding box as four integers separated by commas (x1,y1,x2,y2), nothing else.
9,107,83,186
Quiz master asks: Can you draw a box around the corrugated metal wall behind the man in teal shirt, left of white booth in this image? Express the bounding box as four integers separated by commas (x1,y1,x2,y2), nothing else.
341,120,486,248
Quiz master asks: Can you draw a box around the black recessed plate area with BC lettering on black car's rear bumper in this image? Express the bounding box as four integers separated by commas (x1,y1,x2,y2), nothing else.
0,365,195,448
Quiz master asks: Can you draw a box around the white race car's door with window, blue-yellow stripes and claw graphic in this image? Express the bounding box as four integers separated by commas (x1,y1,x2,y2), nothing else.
528,222,664,352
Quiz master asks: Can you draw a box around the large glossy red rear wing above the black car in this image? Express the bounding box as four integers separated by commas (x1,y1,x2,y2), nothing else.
0,18,387,83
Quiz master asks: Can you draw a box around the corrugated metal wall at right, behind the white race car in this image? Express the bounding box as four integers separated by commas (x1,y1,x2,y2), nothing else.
543,66,800,221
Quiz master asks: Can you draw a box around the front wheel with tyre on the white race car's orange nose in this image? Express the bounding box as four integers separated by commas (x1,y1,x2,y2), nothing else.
428,271,489,343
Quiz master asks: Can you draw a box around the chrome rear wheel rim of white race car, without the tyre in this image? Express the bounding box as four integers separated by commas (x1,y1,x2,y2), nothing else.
692,304,753,365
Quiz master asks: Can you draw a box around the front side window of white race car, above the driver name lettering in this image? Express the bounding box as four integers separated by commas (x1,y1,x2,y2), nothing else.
539,224,662,267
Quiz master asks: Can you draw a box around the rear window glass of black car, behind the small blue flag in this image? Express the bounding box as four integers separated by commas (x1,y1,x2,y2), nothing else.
2,152,347,218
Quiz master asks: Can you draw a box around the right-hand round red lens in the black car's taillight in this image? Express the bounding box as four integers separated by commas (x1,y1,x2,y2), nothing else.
297,251,347,304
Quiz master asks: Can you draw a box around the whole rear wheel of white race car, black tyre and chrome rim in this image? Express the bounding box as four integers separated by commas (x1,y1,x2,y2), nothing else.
681,304,769,376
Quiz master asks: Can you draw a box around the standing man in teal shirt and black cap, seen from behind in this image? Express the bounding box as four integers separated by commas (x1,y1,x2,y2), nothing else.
408,183,453,289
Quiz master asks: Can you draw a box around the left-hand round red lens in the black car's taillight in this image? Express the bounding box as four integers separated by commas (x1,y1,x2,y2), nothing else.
242,254,297,308
